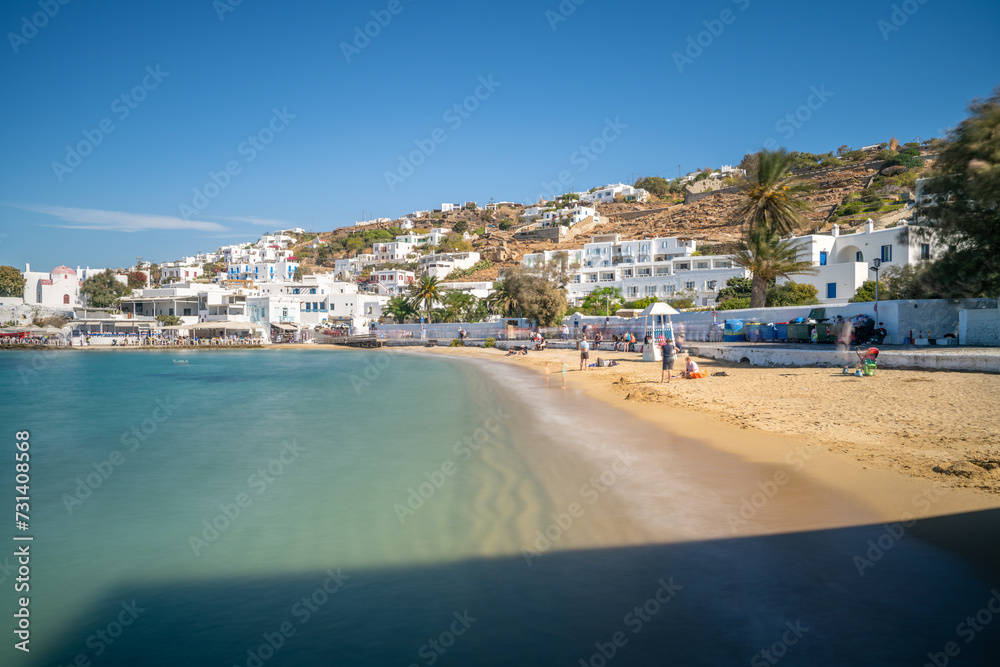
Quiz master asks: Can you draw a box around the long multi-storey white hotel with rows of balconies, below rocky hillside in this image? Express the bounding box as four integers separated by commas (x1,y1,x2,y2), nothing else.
522,234,747,306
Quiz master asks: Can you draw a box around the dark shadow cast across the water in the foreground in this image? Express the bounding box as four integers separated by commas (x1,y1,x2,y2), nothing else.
33,510,1000,667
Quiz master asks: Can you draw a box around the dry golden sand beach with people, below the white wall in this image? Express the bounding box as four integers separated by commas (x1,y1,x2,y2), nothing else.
415,348,1000,520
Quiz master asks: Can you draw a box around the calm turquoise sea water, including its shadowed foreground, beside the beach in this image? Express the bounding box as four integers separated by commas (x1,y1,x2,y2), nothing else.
0,351,1000,667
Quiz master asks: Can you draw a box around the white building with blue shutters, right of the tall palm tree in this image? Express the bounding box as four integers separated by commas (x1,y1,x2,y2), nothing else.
792,220,945,304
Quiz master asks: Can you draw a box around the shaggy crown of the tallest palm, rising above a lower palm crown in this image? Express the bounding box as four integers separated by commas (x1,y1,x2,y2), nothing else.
737,148,812,237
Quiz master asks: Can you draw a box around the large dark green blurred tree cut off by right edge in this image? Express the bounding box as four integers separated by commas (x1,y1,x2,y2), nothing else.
920,88,1000,298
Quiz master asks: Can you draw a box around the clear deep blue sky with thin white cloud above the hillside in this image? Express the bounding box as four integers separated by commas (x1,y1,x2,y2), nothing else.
0,0,1000,270
